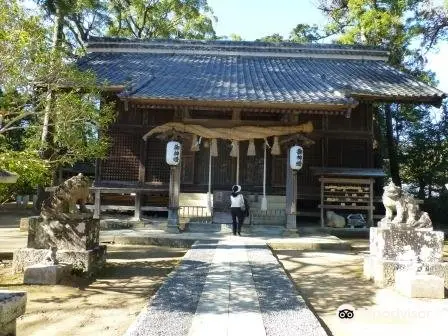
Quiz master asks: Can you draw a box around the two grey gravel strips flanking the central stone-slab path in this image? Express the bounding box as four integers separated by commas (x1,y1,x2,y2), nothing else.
126,241,327,336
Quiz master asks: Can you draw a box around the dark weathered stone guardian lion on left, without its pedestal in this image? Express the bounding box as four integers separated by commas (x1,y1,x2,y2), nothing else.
41,173,90,219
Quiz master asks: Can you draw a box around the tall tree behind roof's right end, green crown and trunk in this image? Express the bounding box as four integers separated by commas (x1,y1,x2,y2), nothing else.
319,0,430,185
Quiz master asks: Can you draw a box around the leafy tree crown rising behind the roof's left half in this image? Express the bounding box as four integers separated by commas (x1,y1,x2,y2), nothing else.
107,0,216,39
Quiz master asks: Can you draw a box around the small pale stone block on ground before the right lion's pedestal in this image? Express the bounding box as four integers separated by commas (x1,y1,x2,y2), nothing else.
395,271,445,299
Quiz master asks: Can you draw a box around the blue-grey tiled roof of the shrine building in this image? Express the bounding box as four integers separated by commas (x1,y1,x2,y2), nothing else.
78,38,444,105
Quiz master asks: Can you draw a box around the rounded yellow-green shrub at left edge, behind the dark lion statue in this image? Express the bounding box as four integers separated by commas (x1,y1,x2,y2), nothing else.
0,150,50,204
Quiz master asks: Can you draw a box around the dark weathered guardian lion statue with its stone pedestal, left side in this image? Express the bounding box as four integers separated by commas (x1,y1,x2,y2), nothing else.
13,174,106,282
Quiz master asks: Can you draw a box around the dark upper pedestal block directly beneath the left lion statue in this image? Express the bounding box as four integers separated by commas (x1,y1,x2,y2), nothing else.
27,217,100,251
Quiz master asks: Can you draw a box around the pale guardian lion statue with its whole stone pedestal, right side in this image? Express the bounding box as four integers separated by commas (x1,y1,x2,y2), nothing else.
364,183,448,298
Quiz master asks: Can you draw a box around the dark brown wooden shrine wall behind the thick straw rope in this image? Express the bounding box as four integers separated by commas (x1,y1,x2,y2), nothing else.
100,101,373,198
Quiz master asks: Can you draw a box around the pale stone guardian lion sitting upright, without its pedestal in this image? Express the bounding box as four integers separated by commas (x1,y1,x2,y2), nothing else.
379,182,432,228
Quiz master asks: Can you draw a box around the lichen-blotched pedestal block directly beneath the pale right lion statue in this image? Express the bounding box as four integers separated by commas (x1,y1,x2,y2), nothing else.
370,227,444,262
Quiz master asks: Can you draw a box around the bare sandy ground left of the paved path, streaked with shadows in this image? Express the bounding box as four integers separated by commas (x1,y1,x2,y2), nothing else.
0,246,186,336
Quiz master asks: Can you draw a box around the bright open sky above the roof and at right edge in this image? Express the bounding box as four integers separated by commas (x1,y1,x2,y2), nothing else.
208,0,448,93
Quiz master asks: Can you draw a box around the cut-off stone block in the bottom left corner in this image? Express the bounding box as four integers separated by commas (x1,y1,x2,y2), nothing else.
0,290,26,336
